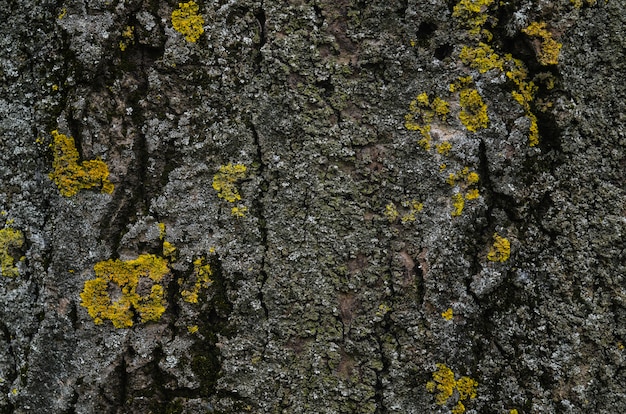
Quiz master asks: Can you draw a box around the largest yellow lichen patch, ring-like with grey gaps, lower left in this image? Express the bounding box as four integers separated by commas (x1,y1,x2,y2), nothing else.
80,254,169,328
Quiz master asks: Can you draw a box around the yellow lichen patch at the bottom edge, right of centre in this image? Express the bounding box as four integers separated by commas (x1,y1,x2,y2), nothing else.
426,364,478,414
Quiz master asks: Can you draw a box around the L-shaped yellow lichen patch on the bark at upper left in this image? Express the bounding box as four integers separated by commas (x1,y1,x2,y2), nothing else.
49,130,113,197
